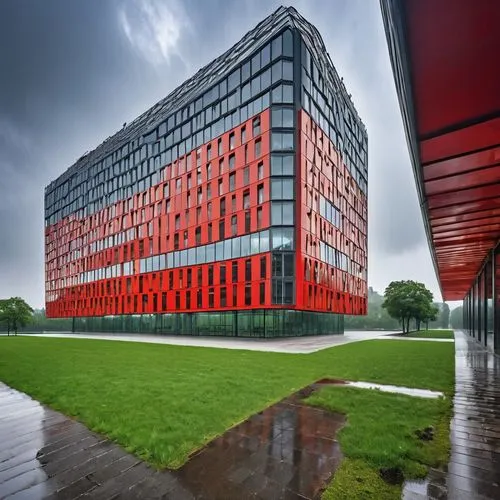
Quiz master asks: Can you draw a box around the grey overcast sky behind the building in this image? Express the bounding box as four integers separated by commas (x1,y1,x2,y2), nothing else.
0,0,450,307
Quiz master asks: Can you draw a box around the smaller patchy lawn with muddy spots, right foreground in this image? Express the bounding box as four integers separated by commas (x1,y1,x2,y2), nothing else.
307,387,452,500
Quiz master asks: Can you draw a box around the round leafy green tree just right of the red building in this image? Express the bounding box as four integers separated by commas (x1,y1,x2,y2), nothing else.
382,280,438,333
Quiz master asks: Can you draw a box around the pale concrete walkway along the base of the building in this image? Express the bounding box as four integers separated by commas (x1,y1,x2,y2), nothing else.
19,331,394,354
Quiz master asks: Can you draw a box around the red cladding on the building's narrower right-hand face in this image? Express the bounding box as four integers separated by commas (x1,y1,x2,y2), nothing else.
296,111,367,314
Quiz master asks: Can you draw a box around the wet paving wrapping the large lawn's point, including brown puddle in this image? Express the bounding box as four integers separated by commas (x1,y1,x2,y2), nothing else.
0,383,345,500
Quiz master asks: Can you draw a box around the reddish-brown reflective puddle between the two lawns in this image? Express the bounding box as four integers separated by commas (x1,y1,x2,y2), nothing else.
175,386,345,499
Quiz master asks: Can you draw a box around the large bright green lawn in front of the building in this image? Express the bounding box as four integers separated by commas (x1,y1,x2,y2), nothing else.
0,337,454,467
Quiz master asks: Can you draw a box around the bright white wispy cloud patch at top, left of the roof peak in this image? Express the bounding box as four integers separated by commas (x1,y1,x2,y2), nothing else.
118,0,187,66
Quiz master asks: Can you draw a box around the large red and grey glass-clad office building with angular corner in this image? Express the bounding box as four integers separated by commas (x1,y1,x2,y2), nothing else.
45,7,367,337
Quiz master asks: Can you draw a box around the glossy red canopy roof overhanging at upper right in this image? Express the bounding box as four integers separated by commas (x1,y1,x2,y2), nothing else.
381,0,500,300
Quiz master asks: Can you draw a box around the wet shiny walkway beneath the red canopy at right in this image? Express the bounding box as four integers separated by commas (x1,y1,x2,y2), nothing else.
403,332,500,500
